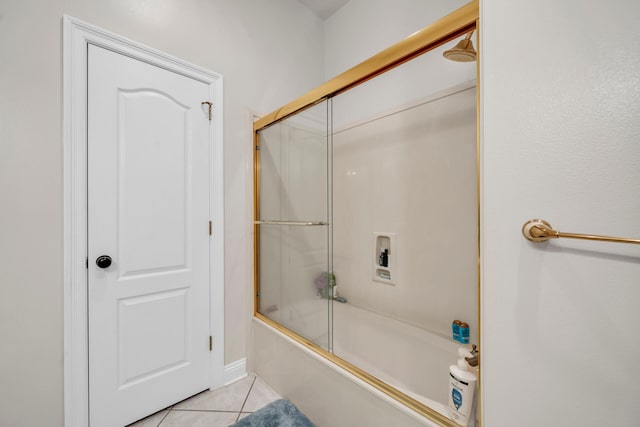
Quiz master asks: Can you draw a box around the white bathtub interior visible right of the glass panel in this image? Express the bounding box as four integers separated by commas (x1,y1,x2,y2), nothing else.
333,302,460,416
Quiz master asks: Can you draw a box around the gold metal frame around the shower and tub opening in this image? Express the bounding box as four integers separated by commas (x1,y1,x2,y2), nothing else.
253,0,482,427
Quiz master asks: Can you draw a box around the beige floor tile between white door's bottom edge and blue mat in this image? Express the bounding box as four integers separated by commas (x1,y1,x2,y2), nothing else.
174,374,255,412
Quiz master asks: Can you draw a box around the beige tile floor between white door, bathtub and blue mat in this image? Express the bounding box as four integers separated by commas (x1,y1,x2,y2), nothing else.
129,374,280,427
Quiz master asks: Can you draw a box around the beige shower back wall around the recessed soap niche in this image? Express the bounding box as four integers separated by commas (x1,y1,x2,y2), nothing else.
333,84,478,343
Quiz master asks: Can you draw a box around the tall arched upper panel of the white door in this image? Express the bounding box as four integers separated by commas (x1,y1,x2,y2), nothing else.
117,90,190,276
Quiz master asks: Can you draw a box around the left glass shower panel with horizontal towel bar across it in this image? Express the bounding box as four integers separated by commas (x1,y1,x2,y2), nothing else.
256,101,334,349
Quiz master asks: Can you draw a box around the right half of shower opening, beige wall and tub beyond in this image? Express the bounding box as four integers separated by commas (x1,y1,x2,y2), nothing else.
331,40,478,416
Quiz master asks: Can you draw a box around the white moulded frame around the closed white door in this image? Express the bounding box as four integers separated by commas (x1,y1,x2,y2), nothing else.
63,15,224,427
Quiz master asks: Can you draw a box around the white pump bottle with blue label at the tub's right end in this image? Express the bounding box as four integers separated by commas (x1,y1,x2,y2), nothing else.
449,348,478,427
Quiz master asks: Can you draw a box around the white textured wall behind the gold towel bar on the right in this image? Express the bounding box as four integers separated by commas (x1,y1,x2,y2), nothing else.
480,0,640,427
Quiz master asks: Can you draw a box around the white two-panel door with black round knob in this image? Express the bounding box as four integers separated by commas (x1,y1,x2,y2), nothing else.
88,45,210,427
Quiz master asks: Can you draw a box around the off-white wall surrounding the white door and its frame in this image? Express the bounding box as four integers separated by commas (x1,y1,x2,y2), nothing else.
0,0,324,427
